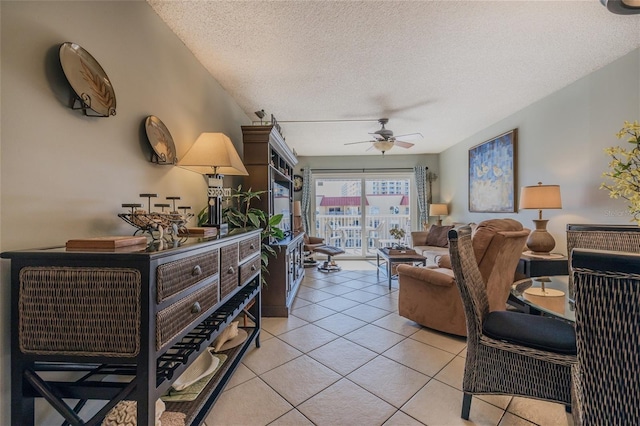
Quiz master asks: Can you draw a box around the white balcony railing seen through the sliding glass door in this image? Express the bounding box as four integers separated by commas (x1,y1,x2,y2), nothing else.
315,214,411,257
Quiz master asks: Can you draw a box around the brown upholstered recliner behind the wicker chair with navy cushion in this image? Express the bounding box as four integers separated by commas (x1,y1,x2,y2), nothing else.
398,219,530,336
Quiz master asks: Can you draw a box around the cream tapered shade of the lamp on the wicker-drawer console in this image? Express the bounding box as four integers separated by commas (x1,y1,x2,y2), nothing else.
178,133,249,176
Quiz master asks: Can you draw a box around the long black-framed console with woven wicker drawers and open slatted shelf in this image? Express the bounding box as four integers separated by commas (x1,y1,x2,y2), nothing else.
2,231,261,425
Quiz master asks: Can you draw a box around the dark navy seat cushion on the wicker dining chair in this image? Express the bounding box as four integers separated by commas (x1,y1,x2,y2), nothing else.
482,311,576,355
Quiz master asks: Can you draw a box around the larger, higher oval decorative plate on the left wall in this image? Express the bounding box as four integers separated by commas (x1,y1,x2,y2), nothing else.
60,42,116,117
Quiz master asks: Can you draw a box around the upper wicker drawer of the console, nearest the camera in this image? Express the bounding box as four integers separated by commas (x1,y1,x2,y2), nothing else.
156,250,218,303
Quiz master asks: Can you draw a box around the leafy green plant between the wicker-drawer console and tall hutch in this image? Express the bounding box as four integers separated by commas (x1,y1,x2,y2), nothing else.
198,185,284,285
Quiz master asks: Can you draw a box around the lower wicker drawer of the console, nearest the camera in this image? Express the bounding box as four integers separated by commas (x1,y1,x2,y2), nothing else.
156,280,220,349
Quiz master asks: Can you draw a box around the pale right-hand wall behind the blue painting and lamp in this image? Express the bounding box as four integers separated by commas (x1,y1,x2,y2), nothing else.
439,49,640,253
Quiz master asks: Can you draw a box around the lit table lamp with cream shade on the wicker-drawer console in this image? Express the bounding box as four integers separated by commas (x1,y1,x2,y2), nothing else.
178,133,249,235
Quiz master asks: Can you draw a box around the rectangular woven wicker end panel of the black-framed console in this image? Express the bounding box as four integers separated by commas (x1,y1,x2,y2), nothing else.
18,266,141,357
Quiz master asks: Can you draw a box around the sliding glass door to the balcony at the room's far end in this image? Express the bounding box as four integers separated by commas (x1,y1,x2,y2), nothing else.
311,172,415,258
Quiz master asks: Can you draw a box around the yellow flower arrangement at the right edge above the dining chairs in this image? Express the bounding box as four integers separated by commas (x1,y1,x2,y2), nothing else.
600,121,640,225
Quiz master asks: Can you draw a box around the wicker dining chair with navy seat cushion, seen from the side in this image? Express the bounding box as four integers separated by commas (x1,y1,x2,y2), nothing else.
449,227,576,420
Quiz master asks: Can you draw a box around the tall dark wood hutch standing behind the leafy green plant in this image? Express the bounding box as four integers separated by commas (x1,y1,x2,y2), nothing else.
242,126,304,316
